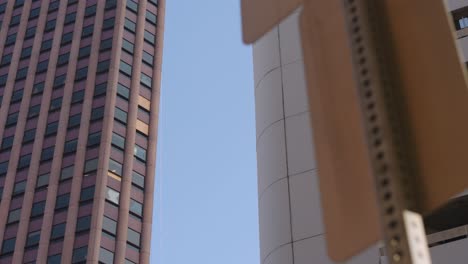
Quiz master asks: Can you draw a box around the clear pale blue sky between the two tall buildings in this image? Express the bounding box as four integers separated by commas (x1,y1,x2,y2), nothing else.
151,0,259,264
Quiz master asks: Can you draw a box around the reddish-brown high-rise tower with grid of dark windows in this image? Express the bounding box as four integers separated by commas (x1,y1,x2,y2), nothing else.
0,0,165,263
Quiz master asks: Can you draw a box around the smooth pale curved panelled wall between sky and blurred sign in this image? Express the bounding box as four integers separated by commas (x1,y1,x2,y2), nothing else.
253,12,379,264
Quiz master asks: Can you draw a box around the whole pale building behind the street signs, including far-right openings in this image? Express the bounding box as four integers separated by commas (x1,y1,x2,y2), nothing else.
253,0,468,264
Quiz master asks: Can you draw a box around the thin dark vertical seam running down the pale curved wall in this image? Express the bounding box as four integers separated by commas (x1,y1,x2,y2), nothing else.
276,25,295,264
